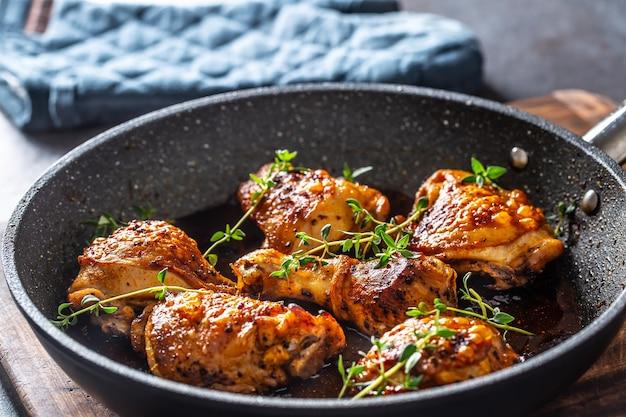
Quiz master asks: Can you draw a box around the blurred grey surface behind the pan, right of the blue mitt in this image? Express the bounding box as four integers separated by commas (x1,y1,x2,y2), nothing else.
401,0,626,101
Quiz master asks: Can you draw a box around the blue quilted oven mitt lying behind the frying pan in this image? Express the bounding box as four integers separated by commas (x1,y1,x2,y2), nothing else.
0,0,482,131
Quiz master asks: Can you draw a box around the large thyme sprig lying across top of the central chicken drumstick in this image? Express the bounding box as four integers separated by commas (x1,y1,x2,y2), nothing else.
270,197,428,278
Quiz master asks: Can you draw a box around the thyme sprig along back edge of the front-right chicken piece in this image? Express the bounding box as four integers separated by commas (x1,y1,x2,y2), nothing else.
406,272,534,336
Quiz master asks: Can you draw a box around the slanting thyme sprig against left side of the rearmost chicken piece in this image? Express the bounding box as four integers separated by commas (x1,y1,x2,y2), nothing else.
204,149,298,265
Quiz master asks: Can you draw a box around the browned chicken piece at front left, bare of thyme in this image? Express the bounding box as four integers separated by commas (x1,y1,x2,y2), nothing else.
131,292,346,393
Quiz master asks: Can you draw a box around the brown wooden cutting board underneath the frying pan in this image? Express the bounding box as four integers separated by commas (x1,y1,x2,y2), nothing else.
0,90,626,417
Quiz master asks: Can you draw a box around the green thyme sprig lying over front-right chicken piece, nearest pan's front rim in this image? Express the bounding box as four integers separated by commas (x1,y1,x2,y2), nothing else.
337,304,456,400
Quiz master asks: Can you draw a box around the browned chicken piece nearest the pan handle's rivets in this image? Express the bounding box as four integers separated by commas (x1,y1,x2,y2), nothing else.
410,170,564,289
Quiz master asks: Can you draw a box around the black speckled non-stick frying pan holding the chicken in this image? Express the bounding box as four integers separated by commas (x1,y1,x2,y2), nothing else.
3,84,626,416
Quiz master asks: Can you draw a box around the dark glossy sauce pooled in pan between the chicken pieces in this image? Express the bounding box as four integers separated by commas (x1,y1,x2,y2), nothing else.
68,191,582,398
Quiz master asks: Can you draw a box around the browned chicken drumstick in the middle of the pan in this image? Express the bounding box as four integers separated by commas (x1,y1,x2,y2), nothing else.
231,249,456,335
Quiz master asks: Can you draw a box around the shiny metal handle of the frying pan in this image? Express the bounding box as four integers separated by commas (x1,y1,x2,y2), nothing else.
583,101,626,164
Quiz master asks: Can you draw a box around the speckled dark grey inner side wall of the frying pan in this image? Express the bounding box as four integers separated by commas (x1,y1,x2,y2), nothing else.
8,89,626,386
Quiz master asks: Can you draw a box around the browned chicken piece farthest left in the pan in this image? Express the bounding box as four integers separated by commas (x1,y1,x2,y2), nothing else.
68,220,234,335
